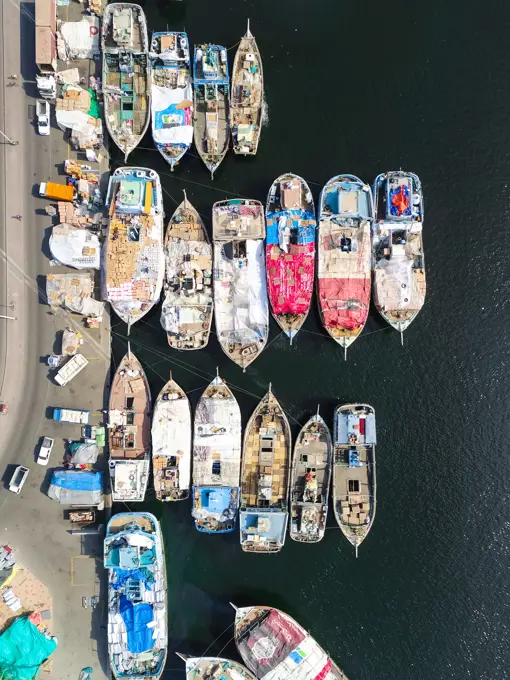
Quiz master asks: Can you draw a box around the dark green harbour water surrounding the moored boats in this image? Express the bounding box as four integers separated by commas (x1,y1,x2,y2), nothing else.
112,0,510,680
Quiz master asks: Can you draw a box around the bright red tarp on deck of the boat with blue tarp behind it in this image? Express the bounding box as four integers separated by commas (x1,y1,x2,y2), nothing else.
266,243,315,314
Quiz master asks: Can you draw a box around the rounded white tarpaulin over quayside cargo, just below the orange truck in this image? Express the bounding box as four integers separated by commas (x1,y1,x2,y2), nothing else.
50,224,101,269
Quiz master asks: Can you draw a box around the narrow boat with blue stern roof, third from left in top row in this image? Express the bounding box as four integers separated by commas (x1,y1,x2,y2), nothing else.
193,44,230,179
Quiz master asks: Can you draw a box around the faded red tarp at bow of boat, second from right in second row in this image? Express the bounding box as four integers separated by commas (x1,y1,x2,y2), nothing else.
318,278,370,330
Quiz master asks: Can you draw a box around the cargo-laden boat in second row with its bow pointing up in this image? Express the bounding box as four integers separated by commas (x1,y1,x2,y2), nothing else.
161,192,213,349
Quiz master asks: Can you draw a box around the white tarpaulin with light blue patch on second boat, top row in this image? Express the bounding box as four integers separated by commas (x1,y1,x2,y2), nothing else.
152,85,193,146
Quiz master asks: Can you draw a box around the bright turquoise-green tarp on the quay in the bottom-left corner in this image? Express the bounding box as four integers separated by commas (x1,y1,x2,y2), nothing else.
0,616,57,680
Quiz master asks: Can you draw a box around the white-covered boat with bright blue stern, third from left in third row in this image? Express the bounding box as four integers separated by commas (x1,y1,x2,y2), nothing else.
191,376,241,534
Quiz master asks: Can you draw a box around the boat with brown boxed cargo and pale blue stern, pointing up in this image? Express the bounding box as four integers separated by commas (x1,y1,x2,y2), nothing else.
239,385,292,553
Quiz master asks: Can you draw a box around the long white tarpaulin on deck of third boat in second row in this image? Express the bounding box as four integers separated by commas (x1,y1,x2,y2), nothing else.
214,240,268,343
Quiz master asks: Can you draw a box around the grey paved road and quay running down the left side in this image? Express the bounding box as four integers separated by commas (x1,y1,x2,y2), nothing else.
0,0,110,679
